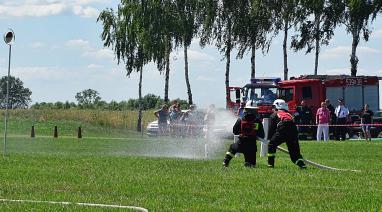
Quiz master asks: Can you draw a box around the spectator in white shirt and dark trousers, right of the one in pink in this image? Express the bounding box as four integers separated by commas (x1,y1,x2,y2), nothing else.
334,99,349,141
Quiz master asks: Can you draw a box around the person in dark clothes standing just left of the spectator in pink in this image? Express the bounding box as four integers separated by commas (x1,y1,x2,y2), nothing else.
296,100,315,139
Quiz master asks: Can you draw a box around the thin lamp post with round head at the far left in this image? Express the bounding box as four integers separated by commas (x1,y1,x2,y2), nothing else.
3,29,15,157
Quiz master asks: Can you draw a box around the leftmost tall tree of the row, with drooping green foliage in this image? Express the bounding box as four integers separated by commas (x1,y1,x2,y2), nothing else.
97,3,152,131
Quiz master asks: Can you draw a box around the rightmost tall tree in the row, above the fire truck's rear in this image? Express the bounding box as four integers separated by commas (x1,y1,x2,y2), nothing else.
344,0,375,76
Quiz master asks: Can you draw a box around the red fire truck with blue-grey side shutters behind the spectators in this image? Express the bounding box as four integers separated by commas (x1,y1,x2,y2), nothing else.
278,75,382,137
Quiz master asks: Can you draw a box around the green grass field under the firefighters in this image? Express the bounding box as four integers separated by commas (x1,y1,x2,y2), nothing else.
0,117,382,211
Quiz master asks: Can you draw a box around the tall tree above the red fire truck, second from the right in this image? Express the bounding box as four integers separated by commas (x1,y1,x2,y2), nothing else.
292,0,345,75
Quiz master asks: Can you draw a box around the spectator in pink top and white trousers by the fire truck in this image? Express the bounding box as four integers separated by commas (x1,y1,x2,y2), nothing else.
316,102,330,141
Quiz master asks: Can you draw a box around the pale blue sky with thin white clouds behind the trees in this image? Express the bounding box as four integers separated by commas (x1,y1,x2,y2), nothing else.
0,0,382,107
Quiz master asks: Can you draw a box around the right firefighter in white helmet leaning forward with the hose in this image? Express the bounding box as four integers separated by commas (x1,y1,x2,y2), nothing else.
268,99,306,168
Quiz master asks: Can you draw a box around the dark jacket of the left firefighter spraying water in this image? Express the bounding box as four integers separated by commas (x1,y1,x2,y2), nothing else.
233,114,264,141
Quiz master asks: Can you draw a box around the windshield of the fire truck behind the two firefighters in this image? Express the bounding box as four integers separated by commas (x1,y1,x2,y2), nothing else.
244,88,277,105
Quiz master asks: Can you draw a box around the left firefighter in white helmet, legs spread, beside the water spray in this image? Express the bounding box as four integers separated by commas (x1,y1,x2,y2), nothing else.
223,101,264,167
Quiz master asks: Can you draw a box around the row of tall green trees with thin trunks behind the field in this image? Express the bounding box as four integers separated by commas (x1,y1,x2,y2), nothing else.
97,0,382,131
